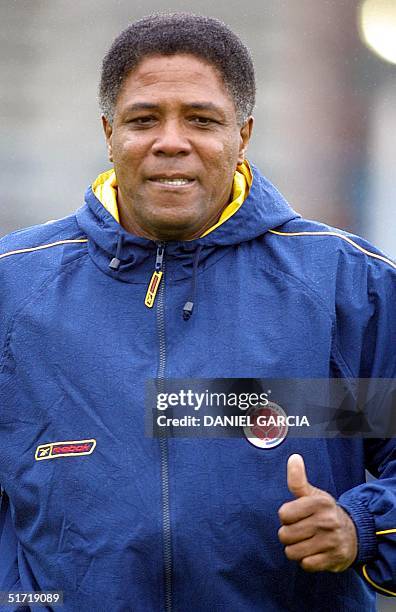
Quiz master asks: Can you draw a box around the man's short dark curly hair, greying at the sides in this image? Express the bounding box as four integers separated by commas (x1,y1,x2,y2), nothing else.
99,13,256,125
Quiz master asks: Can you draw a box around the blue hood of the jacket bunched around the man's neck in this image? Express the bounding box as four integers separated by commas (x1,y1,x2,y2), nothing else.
76,165,300,283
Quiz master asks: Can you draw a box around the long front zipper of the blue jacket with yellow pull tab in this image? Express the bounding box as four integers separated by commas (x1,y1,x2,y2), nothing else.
154,243,172,612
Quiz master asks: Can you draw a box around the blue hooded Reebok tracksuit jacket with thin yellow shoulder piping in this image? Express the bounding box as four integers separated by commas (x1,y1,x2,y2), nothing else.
0,168,396,612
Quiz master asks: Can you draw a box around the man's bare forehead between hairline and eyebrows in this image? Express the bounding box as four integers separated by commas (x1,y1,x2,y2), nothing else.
117,53,233,105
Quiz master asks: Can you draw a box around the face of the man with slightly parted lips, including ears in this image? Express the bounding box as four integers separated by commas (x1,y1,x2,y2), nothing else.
103,54,252,240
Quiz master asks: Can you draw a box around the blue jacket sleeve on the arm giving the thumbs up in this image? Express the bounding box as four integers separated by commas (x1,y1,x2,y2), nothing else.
336,245,396,597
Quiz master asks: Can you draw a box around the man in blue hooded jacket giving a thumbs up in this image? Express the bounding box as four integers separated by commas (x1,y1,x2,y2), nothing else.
0,14,396,612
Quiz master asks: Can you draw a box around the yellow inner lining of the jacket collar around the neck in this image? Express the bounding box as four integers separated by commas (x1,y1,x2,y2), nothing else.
92,160,253,238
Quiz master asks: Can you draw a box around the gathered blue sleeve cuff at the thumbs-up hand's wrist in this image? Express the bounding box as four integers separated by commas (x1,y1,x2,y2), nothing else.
337,495,378,566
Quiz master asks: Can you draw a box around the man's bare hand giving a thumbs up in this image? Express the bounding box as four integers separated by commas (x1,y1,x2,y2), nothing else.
278,455,357,572
